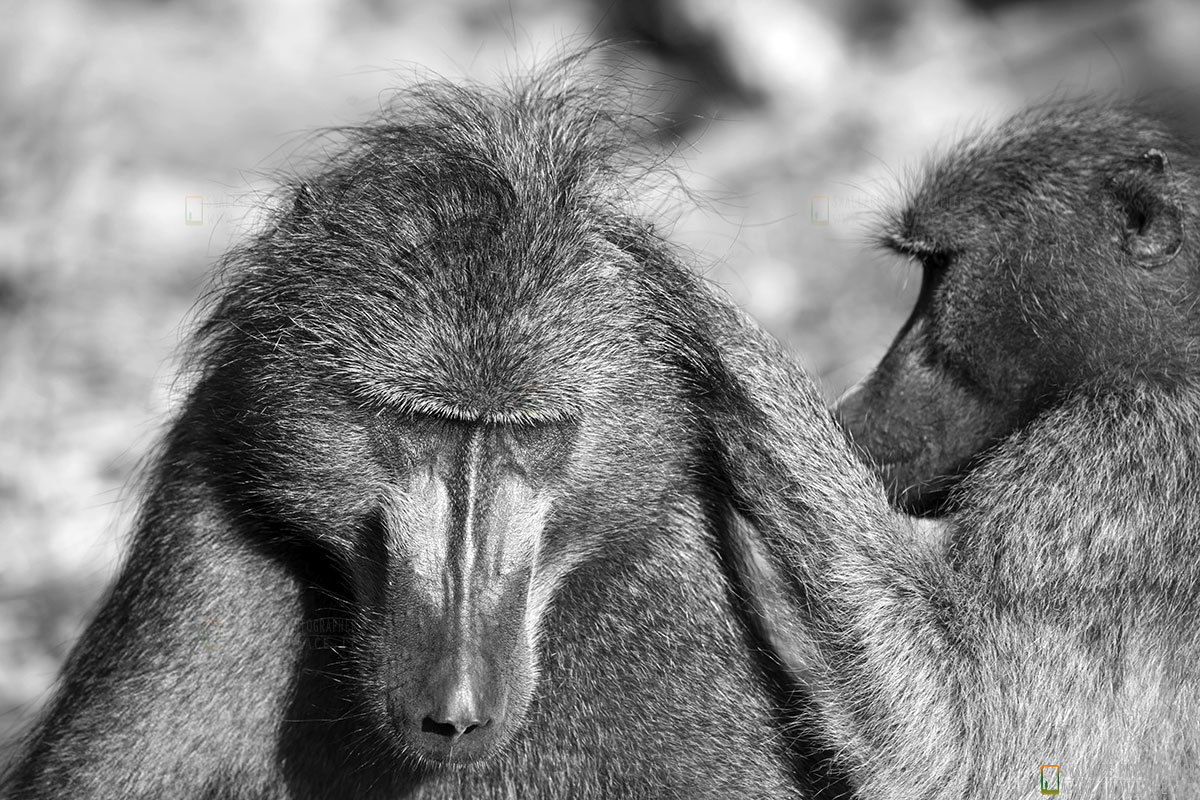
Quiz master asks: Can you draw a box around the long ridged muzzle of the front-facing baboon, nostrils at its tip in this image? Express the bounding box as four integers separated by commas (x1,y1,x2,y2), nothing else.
388,431,544,762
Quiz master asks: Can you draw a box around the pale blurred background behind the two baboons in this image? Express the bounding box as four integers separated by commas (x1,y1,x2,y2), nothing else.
0,0,1200,762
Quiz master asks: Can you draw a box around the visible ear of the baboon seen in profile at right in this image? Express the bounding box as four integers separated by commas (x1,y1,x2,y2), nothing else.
1115,149,1183,267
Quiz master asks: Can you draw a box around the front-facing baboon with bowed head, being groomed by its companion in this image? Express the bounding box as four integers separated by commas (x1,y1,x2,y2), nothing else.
0,67,844,799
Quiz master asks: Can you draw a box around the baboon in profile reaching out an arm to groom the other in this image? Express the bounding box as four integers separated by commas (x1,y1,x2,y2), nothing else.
712,103,1200,799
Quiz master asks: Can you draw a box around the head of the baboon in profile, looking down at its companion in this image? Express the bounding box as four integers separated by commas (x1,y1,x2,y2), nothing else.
836,108,1198,513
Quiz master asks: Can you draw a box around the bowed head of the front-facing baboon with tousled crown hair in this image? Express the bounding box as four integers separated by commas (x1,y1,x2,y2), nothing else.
193,84,670,763
